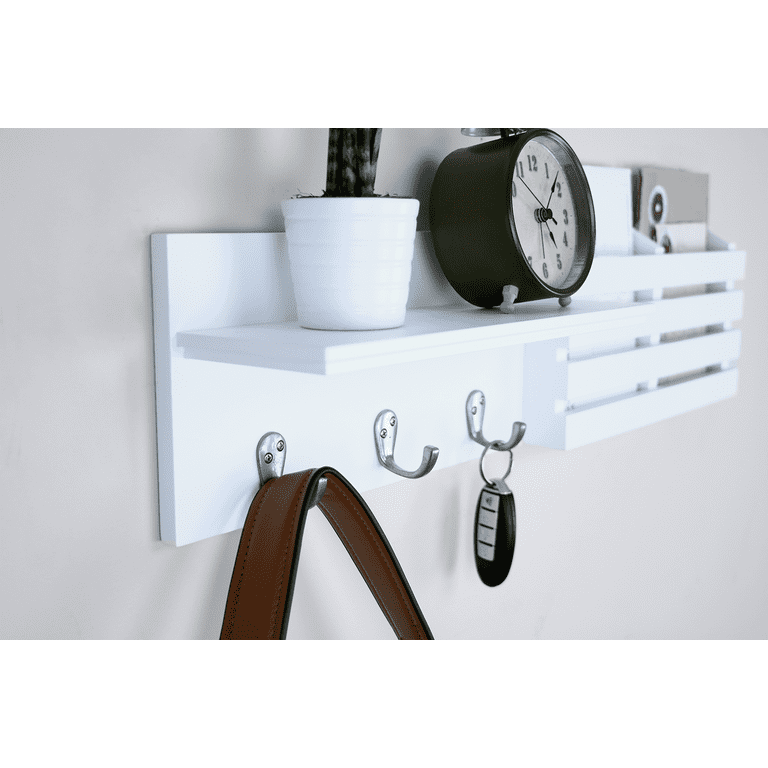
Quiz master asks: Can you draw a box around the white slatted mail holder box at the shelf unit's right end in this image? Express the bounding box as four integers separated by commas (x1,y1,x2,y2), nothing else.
523,232,746,449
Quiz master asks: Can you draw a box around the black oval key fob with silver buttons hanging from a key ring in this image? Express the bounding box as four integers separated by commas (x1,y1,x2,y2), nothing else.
475,480,516,587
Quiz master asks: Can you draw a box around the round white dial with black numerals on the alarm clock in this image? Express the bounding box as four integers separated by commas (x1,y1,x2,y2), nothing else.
510,139,576,288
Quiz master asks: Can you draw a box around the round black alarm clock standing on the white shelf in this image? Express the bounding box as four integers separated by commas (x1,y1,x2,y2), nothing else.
429,128,595,309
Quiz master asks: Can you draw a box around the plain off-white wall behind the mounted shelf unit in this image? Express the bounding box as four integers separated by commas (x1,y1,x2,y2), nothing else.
0,128,768,639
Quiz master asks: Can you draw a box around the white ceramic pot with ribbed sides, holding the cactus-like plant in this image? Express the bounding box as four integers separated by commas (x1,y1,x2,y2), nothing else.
282,197,419,331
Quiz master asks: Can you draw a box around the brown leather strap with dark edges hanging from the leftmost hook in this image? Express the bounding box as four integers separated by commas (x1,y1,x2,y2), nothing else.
221,467,433,640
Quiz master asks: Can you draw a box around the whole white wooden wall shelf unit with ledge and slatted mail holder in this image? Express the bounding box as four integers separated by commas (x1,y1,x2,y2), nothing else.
151,179,745,545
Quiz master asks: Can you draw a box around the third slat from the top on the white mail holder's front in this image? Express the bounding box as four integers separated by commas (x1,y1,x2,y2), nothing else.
568,330,741,402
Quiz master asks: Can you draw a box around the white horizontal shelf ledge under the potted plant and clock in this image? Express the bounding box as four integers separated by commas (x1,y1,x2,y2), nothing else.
176,299,655,374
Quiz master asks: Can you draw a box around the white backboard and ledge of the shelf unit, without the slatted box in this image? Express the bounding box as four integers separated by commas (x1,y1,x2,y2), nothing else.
152,233,650,545
